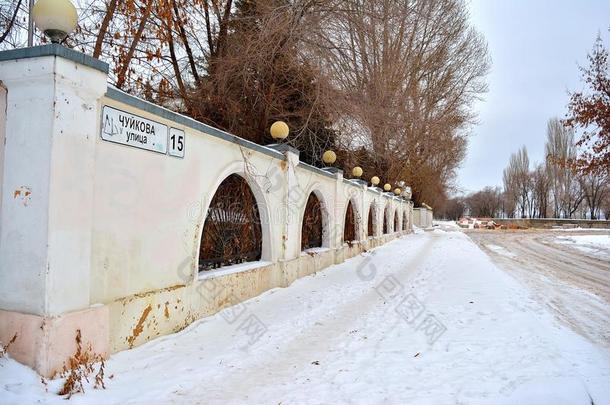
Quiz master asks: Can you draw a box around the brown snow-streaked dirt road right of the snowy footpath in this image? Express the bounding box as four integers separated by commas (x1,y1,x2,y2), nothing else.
466,230,610,347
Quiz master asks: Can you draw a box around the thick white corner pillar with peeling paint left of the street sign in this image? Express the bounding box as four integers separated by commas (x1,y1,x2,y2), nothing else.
0,44,108,376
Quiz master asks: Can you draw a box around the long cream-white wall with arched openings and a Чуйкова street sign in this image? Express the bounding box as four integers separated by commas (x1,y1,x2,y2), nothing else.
0,45,412,376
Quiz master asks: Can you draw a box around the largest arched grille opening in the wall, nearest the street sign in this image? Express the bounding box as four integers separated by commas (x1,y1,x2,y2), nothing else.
199,174,263,271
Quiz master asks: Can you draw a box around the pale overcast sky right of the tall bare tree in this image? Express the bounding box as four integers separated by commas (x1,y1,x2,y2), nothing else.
458,0,610,192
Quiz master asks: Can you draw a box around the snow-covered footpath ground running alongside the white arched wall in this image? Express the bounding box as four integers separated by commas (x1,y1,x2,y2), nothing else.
0,229,610,405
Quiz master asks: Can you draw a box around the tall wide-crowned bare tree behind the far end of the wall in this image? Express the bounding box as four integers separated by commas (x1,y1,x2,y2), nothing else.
312,0,489,204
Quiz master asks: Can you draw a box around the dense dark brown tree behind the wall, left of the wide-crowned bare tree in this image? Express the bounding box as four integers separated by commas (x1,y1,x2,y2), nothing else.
186,0,337,164
